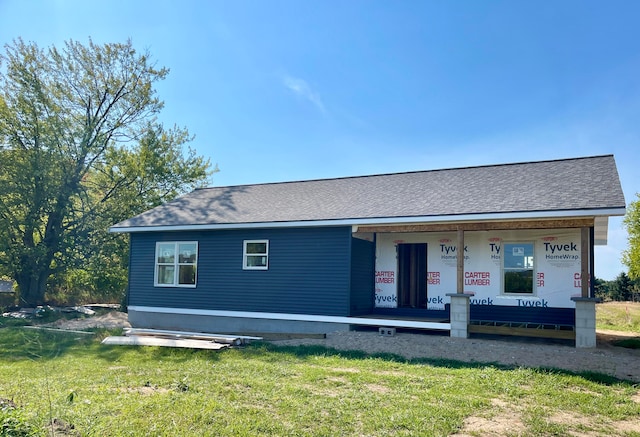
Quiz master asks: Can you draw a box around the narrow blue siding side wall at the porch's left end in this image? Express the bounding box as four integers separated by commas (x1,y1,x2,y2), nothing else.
350,238,375,316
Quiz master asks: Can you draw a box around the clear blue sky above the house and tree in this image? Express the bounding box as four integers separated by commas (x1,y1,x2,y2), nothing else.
0,0,640,279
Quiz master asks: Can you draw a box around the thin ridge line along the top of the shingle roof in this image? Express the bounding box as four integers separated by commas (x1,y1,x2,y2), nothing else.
194,153,614,191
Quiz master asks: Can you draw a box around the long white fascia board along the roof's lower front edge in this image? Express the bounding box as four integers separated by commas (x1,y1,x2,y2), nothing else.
109,208,625,233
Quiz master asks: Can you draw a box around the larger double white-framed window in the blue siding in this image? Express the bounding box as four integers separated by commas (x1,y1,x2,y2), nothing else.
155,241,198,287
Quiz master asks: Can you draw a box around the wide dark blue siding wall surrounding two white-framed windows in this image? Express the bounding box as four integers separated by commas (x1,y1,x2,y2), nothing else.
129,227,351,316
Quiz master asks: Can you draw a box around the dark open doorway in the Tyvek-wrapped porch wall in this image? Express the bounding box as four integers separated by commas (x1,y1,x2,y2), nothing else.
398,243,427,308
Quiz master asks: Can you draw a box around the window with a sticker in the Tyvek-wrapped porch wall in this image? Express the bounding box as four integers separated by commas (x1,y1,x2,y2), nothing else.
503,243,533,294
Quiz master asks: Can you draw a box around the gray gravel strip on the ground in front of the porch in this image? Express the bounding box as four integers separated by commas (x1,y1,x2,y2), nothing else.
273,331,640,382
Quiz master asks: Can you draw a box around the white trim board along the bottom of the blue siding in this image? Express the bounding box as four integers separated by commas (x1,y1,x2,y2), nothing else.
128,305,451,331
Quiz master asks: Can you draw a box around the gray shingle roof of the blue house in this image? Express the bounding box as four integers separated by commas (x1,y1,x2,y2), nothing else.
112,155,625,230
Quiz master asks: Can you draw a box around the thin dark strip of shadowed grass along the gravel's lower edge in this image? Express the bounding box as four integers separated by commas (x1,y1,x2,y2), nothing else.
247,342,638,387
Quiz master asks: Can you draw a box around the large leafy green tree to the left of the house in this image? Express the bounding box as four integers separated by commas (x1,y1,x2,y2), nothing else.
0,40,212,305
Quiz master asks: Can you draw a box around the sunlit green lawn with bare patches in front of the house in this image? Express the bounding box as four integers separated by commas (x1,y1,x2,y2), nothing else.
0,327,640,436
